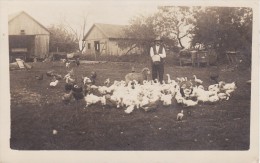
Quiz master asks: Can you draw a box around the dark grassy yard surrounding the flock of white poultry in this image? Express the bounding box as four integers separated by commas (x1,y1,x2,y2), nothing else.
10,62,251,150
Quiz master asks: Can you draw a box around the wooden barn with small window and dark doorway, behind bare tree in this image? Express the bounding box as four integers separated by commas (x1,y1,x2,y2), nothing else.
83,23,140,55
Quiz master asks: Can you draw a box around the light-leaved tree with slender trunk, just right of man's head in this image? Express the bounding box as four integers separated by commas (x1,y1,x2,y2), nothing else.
154,6,193,49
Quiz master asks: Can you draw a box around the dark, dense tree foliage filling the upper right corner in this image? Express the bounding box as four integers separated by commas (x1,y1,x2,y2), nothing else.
192,7,252,58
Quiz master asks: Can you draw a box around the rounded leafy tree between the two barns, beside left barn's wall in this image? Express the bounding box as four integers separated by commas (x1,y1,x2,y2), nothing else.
48,25,77,52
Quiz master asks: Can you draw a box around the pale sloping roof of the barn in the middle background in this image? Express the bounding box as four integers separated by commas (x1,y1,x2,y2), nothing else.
83,23,127,40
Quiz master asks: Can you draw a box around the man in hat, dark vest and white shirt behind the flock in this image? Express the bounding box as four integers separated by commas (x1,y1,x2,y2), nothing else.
150,37,166,83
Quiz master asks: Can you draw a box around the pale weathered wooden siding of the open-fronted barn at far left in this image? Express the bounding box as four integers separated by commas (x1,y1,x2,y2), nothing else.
8,12,50,58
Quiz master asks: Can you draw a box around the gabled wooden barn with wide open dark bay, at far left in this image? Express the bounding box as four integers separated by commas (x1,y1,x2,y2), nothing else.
8,11,50,61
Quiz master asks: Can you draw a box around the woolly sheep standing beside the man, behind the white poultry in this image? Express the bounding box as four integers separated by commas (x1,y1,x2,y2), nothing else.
125,68,150,84
